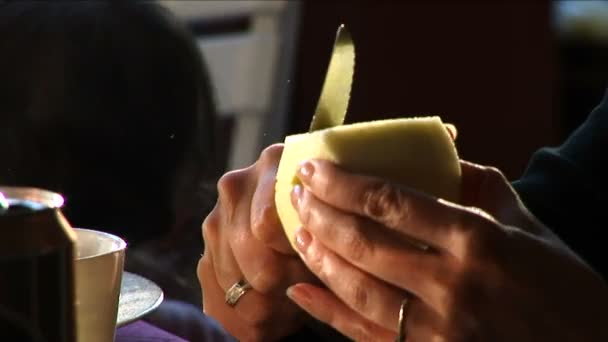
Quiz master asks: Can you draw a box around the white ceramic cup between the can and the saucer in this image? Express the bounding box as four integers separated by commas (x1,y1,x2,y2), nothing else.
74,228,127,342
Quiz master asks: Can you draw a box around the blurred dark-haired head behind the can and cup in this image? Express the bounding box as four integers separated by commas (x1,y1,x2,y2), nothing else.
0,1,220,241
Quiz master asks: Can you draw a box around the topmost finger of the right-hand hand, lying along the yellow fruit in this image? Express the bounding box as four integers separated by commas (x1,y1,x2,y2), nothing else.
298,159,466,249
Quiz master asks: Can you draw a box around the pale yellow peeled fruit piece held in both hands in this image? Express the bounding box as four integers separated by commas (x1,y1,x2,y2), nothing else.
275,116,461,248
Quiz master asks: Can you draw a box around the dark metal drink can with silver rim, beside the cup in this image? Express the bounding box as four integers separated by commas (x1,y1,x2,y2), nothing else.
0,186,76,342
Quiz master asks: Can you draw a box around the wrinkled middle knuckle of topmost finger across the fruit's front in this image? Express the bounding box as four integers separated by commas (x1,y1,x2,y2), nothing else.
362,181,409,224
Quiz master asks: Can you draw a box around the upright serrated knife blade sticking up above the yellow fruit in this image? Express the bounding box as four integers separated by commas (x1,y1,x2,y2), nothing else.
309,24,355,132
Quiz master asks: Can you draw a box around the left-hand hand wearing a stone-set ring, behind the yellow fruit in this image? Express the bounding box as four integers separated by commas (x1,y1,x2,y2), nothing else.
197,145,319,341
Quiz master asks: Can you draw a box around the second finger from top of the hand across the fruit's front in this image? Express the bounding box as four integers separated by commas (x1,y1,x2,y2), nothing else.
292,186,455,302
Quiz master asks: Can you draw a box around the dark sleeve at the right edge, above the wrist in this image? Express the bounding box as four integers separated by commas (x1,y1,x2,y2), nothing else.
513,93,608,279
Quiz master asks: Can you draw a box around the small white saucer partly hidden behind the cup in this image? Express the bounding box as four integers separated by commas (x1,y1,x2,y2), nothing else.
116,272,163,327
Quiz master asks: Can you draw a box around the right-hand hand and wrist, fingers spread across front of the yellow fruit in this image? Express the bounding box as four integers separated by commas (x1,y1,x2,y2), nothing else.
288,160,608,342
